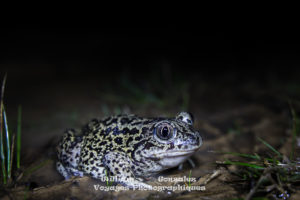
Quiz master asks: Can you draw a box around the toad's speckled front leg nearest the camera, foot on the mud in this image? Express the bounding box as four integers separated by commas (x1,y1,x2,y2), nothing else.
104,151,152,190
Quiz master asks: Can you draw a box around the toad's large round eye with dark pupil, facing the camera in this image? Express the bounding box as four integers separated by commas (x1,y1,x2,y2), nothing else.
154,123,176,142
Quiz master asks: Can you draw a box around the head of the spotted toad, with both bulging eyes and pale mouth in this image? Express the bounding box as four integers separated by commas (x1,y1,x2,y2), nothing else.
141,112,202,169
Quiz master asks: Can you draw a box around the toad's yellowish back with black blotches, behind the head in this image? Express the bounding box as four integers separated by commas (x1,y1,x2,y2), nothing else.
80,115,154,171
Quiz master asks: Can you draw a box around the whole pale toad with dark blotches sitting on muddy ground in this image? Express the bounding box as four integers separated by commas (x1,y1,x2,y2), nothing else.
56,111,202,190
